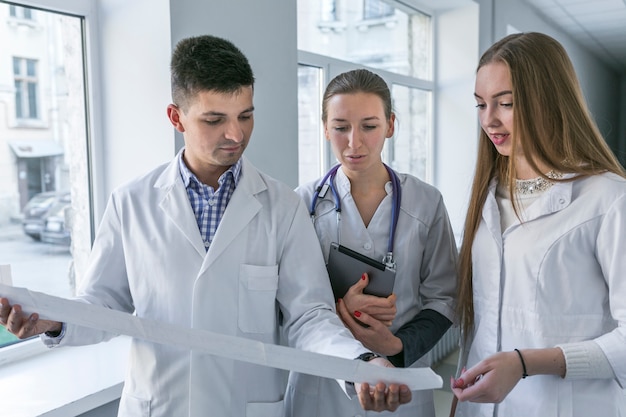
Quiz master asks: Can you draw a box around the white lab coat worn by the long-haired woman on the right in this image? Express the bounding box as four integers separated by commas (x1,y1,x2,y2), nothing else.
456,174,626,417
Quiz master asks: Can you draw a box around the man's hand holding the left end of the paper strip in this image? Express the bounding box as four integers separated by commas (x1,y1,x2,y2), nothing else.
0,298,63,339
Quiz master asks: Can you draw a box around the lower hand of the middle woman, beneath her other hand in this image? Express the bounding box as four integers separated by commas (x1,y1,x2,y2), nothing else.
337,300,403,356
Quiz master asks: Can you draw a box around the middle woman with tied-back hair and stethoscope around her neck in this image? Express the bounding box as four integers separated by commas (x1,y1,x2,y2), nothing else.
286,69,457,417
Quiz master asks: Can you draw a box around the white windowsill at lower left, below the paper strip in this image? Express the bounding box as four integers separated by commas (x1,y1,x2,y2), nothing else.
0,336,130,417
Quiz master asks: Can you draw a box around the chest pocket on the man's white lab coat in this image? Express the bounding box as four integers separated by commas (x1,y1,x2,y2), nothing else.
238,265,278,333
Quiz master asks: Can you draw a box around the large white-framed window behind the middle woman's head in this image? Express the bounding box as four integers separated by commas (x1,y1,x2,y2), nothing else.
298,0,434,184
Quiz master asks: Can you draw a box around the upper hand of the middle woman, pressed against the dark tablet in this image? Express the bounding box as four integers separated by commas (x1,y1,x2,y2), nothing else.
343,274,397,326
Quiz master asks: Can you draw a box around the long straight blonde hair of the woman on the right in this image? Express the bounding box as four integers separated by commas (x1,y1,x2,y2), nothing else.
458,32,626,337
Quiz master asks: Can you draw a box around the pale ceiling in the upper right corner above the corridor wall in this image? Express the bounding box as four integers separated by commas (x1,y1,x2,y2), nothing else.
526,0,626,74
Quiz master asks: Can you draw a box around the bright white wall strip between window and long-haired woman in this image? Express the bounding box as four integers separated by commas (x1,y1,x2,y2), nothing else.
435,3,479,241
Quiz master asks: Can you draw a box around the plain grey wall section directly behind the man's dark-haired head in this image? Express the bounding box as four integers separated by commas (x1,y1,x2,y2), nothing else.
170,0,298,188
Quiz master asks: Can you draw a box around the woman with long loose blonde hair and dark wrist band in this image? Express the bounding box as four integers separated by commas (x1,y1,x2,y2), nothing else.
451,33,626,417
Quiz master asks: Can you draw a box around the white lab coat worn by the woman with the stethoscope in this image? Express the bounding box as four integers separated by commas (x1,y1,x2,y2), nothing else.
285,169,457,417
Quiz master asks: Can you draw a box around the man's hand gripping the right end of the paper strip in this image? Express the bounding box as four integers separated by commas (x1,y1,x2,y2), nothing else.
354,358,411,411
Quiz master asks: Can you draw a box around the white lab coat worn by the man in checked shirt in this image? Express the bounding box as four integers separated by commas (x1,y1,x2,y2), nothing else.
55,154,366,417
